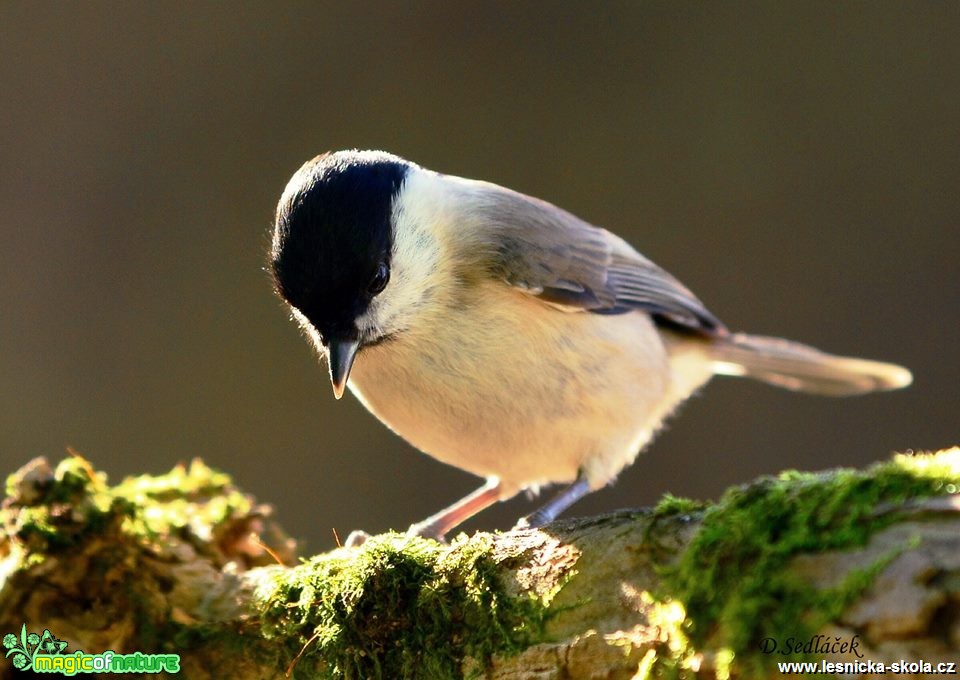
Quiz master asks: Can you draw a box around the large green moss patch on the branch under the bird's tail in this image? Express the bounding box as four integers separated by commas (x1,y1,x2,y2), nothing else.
654,449,960,676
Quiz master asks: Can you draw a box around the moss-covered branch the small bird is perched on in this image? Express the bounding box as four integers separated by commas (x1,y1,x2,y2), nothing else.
0,449,960,680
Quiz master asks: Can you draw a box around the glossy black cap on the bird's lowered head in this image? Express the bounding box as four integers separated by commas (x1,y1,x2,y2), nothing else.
270,151,411,342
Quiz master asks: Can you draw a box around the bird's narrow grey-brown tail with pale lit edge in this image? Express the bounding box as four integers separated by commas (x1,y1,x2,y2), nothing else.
710,333,913,397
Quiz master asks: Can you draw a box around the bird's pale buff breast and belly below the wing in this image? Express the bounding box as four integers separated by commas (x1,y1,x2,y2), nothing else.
350,282,706,497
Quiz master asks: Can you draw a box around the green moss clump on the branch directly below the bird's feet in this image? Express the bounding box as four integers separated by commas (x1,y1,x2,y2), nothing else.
257,534,546,680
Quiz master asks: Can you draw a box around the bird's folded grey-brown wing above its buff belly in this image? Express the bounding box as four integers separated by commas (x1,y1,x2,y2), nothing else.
472,185,727,336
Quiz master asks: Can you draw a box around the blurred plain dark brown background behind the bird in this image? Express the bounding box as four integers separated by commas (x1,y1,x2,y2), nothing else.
0,2,960,550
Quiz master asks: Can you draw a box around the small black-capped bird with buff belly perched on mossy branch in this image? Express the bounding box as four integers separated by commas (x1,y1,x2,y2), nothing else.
269,150,912,539
